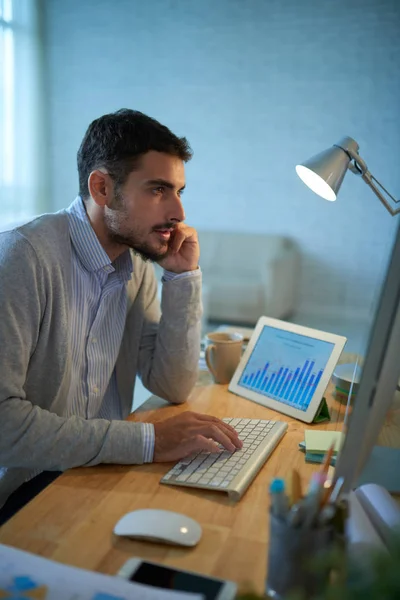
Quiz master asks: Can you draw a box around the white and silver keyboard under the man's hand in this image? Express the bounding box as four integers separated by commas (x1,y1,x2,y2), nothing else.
161,419,288,500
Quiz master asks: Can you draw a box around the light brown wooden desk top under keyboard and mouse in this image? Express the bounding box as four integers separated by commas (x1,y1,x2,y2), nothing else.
0,374,345,593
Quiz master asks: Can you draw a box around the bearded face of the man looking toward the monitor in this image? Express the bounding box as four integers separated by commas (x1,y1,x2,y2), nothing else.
104,151,185,261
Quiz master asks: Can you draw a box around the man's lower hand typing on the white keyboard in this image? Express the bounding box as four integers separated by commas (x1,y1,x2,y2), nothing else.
154,411,242,462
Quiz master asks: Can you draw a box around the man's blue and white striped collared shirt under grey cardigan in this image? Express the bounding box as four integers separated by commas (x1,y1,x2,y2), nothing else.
65,196,155,462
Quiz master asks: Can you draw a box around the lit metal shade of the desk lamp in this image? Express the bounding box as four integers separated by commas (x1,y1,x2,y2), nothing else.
296,146,351,201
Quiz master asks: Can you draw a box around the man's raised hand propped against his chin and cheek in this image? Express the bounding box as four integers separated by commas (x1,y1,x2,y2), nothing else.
158,223,200,273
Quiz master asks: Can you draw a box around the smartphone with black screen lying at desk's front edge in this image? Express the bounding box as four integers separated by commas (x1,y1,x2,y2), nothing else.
118,558,237,600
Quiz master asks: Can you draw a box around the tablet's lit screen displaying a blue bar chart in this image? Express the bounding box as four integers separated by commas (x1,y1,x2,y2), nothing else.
238,326,335,411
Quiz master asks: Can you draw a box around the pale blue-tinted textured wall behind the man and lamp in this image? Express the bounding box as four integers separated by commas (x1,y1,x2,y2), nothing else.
45,0,400,324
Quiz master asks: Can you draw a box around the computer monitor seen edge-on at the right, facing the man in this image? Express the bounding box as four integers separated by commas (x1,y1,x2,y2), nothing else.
335,224,400,493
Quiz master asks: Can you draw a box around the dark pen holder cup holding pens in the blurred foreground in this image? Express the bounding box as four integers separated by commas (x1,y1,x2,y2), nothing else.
265,514,334,600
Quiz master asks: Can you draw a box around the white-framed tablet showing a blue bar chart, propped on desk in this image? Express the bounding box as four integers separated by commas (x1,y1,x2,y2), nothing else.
229,317,347,423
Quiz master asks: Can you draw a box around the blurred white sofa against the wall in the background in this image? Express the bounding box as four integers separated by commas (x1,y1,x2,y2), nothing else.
198,231,300,324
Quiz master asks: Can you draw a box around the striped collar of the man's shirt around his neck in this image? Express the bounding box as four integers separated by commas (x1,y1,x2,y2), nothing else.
67,196,133,281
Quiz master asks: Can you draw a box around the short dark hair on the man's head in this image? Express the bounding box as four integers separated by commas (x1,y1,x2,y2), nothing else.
77,108,192,201
